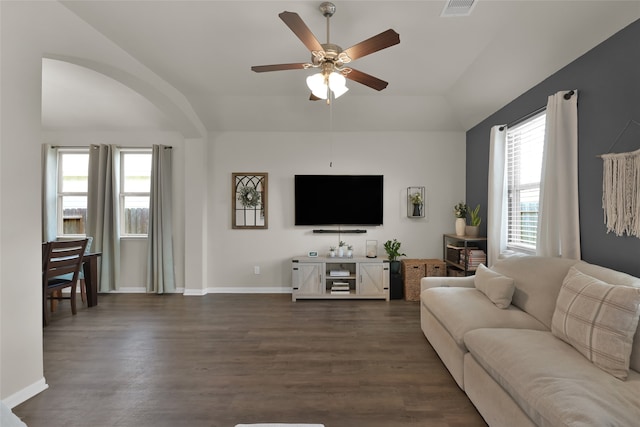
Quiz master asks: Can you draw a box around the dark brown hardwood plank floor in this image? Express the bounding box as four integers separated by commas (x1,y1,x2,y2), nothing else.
13,294,486,427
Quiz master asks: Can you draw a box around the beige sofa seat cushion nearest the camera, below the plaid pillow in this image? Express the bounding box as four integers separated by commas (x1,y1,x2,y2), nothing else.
464,328,640,427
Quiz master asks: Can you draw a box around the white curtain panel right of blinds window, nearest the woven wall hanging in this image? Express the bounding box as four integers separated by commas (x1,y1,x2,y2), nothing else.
536,90,580,259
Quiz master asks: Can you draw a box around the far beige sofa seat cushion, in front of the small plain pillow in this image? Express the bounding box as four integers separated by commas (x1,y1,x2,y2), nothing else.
420,288,547,351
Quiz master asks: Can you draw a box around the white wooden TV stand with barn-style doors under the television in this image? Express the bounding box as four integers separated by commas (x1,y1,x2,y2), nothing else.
291,256,389,301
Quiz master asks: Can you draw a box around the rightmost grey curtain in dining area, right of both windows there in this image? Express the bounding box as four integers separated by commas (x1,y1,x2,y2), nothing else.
147,145,175,294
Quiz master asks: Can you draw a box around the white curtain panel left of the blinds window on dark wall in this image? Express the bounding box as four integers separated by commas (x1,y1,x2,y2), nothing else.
487,125,507,265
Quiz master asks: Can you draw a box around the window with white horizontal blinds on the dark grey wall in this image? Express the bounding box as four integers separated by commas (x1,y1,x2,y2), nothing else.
507,111,546,252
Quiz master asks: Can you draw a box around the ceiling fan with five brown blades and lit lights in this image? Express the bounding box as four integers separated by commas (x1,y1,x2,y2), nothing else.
251,2,400,103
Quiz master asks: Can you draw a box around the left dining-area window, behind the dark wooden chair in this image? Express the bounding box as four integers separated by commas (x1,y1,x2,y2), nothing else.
57,149,89,236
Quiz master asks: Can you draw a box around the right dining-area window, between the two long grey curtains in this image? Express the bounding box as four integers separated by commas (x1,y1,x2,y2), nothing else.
120,149,151,237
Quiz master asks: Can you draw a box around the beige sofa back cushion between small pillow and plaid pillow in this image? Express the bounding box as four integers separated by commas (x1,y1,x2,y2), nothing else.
491,256,578,329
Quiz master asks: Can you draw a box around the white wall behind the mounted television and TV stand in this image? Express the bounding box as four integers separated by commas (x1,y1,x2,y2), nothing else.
207,132,465,292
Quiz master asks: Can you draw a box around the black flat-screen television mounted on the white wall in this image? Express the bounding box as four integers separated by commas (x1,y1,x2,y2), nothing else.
295,175,383,225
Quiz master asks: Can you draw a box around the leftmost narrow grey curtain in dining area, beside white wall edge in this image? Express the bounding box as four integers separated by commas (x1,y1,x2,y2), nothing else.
42,144,58,242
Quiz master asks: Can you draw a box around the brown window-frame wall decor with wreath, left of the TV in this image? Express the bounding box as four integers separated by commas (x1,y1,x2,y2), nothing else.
231,172,269,229
